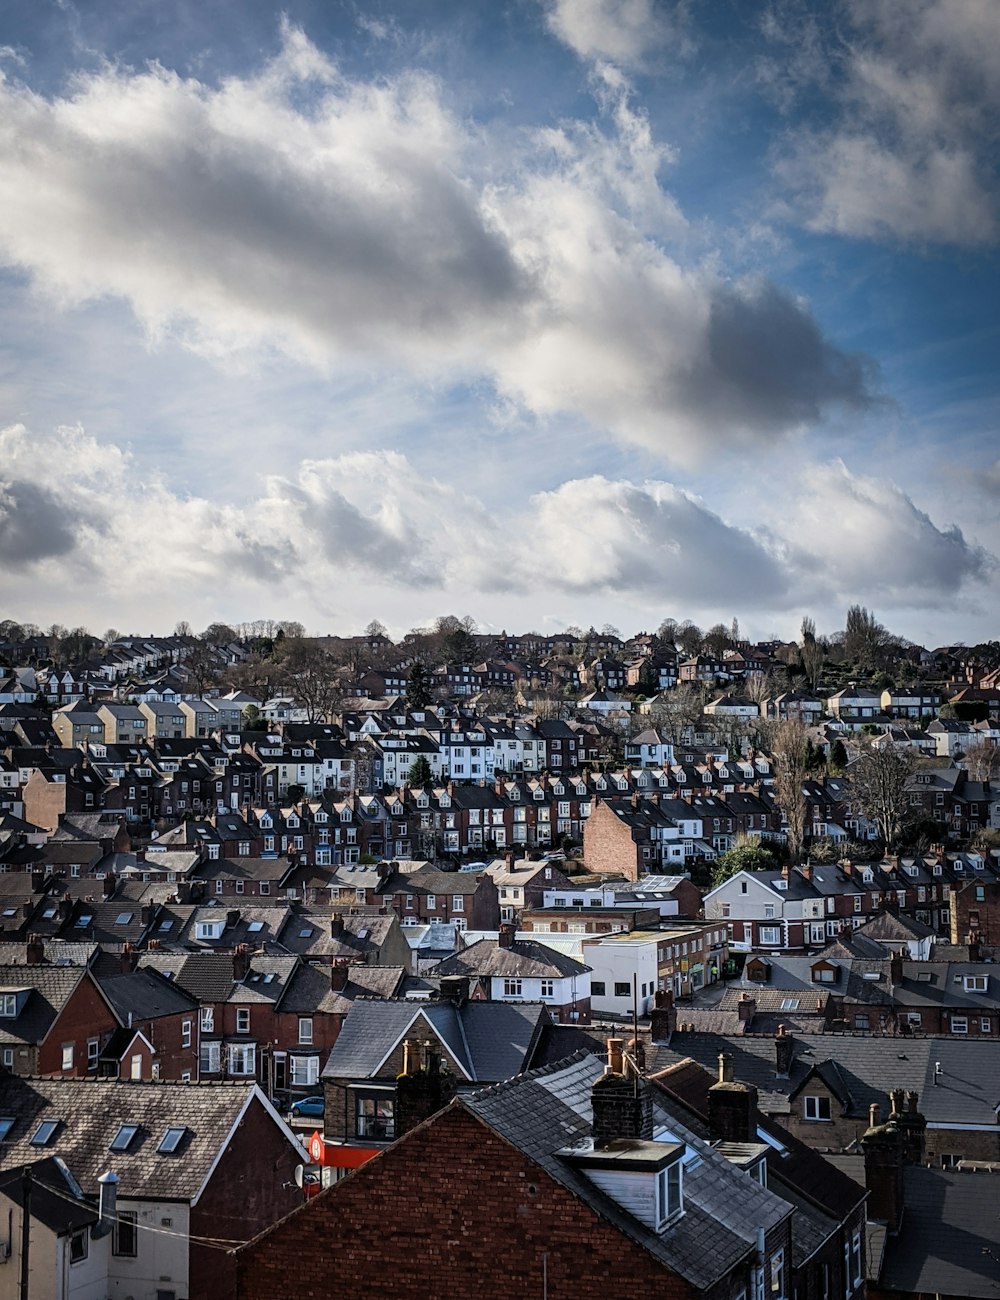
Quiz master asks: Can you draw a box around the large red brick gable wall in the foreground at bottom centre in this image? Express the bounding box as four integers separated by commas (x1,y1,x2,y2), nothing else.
235,1104,697,1300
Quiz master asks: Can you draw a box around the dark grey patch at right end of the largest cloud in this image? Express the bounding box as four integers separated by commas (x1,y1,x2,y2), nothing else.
681,282,879,429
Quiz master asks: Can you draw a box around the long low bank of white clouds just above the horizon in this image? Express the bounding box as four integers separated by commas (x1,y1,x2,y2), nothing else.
0,425,995,627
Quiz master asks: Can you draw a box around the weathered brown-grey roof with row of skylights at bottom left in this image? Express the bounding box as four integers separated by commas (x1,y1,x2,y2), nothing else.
0,1076,293,1201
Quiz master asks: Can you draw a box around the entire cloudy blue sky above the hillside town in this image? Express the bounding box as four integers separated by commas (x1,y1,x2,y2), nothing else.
0,0,1000,645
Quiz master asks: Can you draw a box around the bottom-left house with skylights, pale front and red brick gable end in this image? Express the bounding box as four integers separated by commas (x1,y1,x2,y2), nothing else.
0,1078,303,1300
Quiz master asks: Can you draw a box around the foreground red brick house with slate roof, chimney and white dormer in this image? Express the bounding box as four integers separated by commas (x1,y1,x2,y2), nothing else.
238,1052,795,1300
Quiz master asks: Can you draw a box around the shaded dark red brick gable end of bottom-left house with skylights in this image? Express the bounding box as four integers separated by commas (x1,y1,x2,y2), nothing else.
189,1101,306,1300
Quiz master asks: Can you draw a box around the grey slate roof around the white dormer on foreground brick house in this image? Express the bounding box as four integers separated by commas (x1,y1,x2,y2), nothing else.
463,1053,791,1288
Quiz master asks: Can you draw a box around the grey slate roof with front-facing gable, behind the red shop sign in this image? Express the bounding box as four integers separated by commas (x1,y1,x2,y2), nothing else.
322,998,549,1083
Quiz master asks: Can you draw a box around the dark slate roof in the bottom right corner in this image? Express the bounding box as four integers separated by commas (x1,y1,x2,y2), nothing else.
878,1166,1000,1297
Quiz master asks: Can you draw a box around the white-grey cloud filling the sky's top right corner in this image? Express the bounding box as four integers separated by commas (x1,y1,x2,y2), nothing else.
769,0,1000,246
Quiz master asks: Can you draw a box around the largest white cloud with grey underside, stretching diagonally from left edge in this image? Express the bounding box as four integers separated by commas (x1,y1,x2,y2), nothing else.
0,27,871,462
